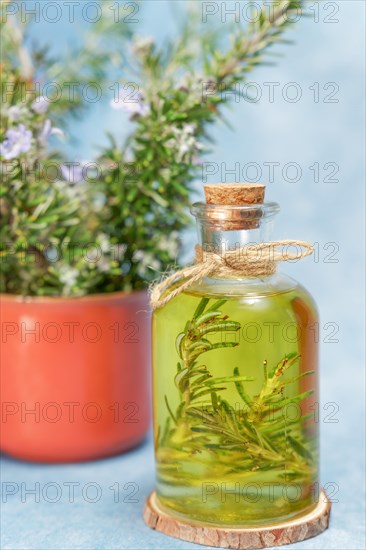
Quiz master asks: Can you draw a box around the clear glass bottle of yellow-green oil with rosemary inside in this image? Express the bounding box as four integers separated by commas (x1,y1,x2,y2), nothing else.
153,187,318,527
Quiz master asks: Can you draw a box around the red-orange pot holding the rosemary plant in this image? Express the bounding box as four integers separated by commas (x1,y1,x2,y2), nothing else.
0,292,150,462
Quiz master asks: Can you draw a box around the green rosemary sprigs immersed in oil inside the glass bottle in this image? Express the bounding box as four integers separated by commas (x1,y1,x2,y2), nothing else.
156,297,315,483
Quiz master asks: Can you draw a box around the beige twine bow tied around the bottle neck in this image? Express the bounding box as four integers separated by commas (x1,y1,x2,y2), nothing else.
150,240,313,309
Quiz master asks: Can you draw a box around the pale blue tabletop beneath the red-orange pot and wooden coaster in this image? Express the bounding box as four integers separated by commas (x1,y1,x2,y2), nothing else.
1,424,365,550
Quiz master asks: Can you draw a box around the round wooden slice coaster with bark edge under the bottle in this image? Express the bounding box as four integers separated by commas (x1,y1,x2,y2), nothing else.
144,491,331,549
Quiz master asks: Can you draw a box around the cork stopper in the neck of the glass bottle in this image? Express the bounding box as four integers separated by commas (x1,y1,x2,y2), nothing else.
204,183,266,230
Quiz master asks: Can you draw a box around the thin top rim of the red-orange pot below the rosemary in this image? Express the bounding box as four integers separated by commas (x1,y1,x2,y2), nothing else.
0,289,147,304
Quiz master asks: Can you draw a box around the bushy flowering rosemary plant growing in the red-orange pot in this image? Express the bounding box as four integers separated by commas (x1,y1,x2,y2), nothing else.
0,0,303,296
